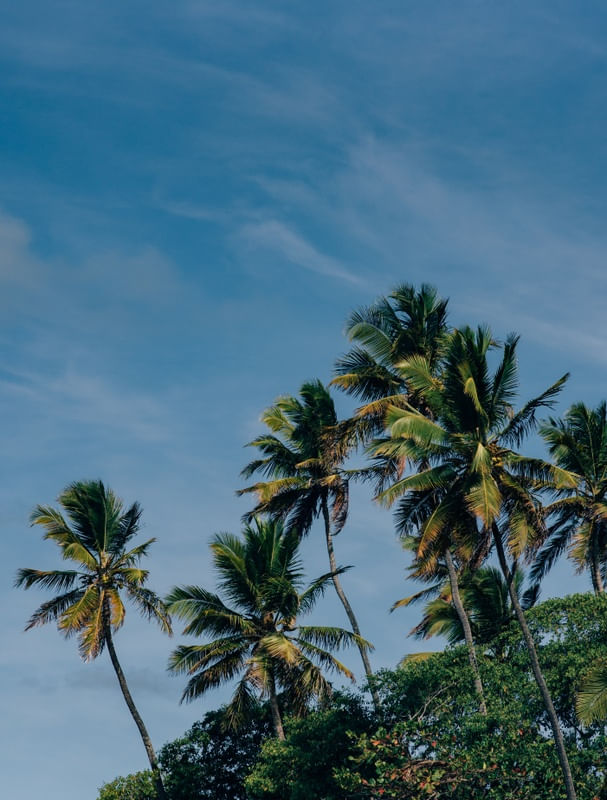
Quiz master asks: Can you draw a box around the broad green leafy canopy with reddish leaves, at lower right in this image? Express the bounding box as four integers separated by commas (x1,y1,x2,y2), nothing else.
336,595,607,800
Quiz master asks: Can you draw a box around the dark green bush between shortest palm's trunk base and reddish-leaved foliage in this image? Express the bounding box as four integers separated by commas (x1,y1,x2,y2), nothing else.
246,695,372,800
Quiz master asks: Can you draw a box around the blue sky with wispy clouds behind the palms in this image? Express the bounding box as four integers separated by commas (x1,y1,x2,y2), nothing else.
0,0,607,800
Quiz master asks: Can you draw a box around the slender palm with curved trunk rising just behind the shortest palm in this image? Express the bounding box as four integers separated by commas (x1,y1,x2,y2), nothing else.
238,380,379,710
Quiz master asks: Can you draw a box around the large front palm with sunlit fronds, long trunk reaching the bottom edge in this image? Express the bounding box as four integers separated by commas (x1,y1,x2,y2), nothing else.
381,328,576,800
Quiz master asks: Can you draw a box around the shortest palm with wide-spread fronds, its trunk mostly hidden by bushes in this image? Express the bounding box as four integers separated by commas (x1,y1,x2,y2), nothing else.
167,519,370,739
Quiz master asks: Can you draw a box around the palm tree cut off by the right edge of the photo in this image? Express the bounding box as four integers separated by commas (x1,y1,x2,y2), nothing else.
532,402,607,594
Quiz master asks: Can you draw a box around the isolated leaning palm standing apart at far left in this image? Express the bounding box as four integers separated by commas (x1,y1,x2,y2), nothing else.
16,481,171,800
